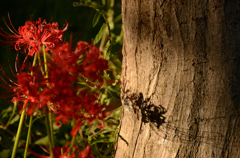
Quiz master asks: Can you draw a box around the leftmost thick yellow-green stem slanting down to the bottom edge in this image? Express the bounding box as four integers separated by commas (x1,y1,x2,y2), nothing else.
11,102,27,158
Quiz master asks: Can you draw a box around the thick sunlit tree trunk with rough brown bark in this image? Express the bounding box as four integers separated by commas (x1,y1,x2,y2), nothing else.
115,0,240,158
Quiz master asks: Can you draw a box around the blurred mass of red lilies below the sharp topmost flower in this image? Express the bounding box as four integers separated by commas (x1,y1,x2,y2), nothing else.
9,41,108,136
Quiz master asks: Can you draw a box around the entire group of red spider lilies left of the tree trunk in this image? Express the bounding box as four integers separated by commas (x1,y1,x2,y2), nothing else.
0,15,113,158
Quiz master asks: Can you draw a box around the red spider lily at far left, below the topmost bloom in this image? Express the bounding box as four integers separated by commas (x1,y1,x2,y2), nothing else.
0,61,50,115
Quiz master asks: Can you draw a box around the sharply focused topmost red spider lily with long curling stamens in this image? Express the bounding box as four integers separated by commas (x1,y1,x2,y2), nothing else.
0,14,68,56
